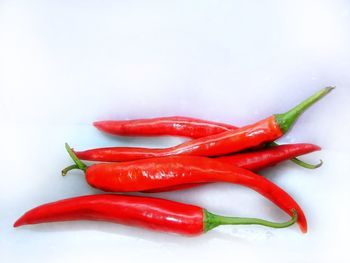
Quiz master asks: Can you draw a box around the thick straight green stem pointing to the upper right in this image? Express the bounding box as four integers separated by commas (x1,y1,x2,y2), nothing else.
274,87,335,133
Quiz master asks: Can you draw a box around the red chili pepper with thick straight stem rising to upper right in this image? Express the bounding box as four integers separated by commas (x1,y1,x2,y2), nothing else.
75,87,333,162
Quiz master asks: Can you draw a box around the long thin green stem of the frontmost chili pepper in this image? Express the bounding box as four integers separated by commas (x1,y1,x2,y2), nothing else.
203,209,298,232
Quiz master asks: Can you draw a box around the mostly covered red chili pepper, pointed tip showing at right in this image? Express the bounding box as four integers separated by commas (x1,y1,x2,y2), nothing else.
145,143,322,193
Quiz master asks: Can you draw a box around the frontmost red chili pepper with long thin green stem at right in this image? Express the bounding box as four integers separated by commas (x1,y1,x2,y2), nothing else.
14,194,298,236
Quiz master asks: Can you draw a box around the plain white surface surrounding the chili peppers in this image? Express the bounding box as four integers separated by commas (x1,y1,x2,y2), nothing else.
0,0,350,262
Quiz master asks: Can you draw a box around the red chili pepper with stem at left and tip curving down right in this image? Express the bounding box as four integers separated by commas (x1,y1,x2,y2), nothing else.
62,144,307,232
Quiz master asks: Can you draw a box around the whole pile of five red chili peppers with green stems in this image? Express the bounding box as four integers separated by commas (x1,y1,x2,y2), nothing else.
14,87,334,235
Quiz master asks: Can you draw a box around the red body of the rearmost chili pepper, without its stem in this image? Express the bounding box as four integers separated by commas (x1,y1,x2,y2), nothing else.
93,116,237,139
